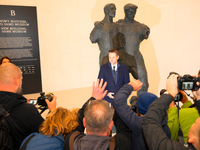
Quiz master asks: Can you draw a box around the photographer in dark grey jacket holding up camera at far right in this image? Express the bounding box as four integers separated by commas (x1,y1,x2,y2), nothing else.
142,74,200,150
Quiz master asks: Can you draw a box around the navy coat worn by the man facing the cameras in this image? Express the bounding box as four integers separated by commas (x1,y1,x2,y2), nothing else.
98,62,130,103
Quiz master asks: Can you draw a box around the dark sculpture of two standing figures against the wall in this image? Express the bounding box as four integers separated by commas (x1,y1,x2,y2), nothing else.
90,3,150,96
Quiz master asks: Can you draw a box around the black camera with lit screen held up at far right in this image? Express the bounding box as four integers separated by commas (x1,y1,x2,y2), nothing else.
178,75,200,91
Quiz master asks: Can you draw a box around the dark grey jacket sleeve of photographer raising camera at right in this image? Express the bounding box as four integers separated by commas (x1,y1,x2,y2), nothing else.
142,94,195,150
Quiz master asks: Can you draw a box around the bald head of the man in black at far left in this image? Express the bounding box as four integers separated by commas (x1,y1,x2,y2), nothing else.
0,63,22,93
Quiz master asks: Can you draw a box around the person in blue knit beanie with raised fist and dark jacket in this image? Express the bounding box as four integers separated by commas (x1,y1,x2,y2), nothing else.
112,79,170,150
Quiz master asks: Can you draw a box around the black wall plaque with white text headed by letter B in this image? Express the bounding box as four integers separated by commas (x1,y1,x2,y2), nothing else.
0,5,42,94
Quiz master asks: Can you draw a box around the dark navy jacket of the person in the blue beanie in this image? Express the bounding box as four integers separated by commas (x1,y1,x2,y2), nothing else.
112,84,171,150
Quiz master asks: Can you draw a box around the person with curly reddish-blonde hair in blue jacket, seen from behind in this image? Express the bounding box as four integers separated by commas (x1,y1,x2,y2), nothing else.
21,107,78,150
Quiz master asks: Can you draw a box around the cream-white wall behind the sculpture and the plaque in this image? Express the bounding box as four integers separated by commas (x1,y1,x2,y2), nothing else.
0,0,200,107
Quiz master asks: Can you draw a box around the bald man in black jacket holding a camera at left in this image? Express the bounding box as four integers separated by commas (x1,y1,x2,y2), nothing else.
0,63,56,149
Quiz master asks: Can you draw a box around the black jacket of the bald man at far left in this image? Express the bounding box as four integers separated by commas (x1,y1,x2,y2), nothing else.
0,91,44,149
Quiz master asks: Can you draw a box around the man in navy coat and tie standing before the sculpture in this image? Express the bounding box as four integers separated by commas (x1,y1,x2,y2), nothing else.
98,49,130,103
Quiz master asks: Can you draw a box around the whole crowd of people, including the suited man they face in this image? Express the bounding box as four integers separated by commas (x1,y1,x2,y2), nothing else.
0,55,200,150
